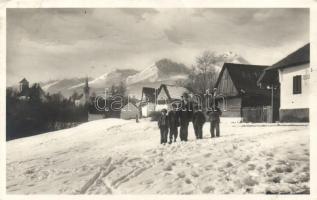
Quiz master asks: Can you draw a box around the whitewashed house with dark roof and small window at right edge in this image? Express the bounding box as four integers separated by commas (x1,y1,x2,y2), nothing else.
258,43,311,122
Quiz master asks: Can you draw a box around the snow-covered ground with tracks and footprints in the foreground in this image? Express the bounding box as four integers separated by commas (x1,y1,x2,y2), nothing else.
7,119,310,194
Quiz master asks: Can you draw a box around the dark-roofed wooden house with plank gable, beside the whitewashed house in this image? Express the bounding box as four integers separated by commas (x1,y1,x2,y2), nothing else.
215,63,273,122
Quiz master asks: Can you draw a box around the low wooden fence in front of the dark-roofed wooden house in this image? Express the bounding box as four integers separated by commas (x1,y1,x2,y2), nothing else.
241,106,273,123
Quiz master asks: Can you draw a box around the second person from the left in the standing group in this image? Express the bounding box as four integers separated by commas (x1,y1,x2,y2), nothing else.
168,104,179,143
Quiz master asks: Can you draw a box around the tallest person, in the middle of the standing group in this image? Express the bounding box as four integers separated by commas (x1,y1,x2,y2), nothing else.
179,93,193,141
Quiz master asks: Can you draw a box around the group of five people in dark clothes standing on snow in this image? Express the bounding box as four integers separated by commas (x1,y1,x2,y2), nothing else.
158,93,221,144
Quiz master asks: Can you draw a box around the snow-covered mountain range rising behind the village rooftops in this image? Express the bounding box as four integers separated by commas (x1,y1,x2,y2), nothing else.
41,52,248,97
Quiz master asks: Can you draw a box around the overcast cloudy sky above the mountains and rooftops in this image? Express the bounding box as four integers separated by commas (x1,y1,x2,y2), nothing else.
7,8,309,85
